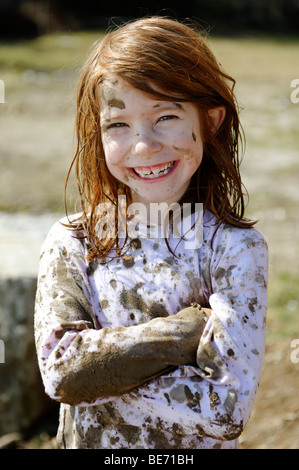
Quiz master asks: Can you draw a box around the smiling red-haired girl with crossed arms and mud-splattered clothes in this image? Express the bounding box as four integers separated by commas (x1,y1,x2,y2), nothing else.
35,17,267,449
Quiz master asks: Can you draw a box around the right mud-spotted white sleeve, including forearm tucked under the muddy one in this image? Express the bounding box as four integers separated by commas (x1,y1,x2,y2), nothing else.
126,226,268,440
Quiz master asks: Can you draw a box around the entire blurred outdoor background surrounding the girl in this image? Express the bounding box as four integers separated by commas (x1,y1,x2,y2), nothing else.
0,0,299,449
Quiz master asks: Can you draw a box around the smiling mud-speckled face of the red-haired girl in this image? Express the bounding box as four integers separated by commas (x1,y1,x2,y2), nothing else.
99,80,203,203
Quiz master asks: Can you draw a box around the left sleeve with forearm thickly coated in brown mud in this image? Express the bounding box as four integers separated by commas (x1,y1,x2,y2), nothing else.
35,220,206,405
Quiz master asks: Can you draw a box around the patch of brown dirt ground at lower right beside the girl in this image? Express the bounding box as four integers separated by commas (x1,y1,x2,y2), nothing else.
240,339,299,449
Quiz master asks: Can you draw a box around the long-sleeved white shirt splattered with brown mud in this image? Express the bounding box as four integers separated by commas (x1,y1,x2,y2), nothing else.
35,212,267,449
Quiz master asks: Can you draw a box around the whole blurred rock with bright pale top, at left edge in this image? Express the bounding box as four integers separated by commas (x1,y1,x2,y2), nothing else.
0,213,58,436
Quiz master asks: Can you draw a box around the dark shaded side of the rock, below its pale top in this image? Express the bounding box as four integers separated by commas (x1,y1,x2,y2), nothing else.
0,277,50,435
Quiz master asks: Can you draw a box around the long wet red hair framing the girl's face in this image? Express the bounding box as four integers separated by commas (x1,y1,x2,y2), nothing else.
66,17,255,259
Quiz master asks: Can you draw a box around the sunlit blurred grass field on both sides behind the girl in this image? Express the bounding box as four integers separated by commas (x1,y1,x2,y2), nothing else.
0,31,299,339
